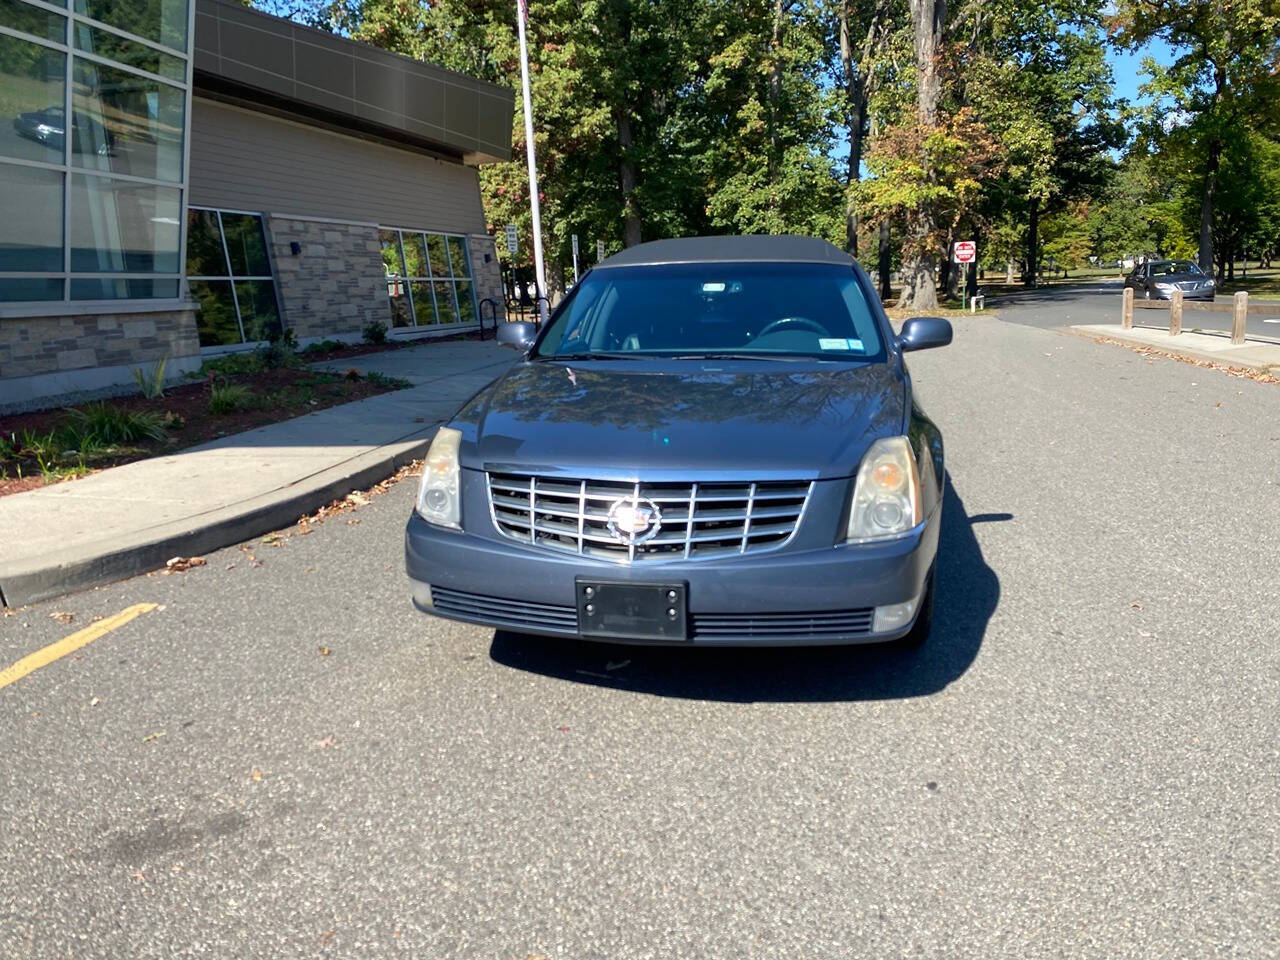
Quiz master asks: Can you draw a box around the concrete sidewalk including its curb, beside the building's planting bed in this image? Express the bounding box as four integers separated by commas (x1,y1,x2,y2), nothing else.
0,340,515,607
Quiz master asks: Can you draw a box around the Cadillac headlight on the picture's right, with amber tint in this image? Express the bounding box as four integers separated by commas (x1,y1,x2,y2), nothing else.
845,436,924,543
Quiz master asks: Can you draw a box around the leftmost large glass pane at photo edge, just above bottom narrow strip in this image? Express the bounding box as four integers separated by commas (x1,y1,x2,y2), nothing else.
0,164,63,273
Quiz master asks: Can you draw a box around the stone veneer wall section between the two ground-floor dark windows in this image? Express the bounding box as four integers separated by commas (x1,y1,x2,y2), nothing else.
268,215,390,339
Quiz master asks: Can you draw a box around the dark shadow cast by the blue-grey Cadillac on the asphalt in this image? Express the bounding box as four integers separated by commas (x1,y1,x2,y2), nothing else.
489,476,1012,703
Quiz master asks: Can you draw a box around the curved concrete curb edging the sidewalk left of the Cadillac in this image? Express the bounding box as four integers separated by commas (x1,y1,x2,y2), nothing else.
0,424,439,607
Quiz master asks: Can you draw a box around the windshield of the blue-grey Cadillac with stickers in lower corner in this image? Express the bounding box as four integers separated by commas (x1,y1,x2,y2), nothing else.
535,262,883,361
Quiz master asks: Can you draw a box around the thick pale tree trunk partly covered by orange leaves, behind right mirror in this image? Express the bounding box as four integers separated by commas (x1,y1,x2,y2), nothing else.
901,0,947,310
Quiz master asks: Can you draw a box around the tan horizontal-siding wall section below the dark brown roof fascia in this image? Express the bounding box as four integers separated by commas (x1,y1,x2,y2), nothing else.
189,97,485,233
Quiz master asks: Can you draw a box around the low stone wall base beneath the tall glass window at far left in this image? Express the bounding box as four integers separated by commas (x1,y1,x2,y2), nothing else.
0,310,200,380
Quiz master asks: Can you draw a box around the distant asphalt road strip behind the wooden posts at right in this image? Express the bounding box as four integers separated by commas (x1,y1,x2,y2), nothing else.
987,279,1280,340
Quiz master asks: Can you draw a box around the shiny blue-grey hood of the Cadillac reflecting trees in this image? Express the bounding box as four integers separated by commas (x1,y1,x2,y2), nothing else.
454,361,906,480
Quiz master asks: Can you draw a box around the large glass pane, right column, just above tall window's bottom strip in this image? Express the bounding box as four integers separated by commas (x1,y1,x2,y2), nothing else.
70,174,182,274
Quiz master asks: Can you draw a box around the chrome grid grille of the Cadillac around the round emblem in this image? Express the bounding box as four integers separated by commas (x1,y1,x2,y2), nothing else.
488,474,812,563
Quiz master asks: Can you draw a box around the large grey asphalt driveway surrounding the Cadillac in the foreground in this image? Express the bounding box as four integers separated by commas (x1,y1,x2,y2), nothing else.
0,317,1280,960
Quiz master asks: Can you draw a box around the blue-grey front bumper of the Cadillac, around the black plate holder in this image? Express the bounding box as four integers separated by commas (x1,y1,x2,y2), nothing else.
404,496,942,646
